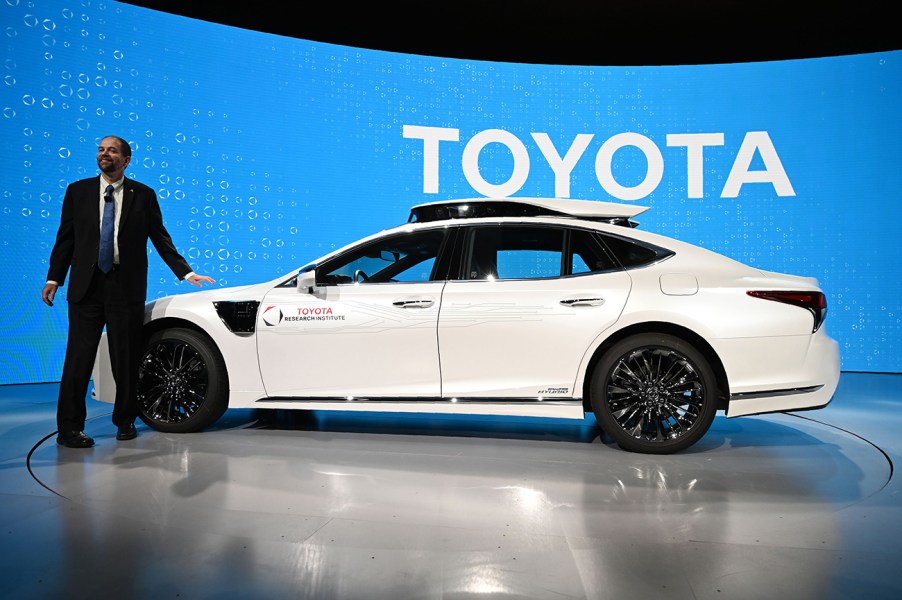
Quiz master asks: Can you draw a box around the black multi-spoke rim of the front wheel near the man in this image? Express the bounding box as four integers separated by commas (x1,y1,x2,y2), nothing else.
138,340,209,423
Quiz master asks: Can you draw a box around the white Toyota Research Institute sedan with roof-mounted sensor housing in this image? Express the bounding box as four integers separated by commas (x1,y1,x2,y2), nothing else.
94,198,840,454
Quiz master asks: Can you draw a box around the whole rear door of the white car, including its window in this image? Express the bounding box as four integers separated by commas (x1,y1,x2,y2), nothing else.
438,224,631,399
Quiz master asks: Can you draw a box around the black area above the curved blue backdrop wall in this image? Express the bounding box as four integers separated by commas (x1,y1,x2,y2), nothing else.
116,0,902,66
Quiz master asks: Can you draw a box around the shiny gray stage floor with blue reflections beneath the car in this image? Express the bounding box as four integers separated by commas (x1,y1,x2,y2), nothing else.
0,373,902,600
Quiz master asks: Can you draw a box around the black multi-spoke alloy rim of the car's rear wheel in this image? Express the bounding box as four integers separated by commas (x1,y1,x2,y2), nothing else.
605,347,706,443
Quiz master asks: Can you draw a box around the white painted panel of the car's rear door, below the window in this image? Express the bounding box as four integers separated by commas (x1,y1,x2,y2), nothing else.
439,271,630,399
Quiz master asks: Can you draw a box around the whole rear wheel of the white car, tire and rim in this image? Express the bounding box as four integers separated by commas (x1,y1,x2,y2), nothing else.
590,333,718,454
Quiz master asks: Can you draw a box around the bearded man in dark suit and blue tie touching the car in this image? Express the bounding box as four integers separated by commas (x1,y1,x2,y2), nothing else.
41,136,213,448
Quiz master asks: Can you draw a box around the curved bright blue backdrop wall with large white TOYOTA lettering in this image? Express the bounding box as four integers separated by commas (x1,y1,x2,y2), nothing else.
0,0,902,384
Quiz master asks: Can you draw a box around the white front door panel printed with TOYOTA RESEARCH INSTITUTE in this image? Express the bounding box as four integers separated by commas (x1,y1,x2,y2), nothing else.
256,282,445,397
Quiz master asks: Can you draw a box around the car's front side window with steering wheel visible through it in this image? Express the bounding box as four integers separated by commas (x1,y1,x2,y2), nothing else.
316,229,445,285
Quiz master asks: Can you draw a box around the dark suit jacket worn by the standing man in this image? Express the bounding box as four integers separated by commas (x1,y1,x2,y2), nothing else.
47,175,191,303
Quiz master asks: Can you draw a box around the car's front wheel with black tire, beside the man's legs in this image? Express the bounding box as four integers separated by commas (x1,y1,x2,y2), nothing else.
138,328,229,433
